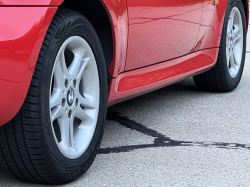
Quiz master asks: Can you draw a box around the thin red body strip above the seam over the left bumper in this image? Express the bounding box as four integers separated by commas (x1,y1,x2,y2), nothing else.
0,0,63,6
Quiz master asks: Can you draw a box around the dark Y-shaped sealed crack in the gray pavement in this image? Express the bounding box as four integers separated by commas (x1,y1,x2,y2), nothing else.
99,111,250,154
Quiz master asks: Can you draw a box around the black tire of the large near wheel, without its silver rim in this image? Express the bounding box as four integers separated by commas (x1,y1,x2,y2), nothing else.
0,9,108,184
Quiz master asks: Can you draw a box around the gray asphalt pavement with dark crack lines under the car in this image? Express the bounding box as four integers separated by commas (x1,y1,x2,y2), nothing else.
0,20,250,187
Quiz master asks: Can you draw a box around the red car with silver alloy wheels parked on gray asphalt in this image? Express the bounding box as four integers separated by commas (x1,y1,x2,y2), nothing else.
0,0,249,184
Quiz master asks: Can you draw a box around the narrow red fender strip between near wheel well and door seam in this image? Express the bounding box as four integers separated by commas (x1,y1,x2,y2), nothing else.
103,0,128,77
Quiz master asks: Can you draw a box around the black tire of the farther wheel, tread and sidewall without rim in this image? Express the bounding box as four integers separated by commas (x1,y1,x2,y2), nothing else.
193,0,246,92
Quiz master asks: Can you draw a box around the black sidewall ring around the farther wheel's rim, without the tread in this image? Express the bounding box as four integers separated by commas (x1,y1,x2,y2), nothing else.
222,0,246,90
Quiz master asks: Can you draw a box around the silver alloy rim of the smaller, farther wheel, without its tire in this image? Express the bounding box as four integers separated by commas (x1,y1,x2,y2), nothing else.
226,7,243,78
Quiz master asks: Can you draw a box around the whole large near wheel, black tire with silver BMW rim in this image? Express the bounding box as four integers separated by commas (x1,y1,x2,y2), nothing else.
0,9,108,184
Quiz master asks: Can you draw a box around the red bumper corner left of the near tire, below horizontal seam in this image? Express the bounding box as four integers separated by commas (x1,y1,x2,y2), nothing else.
0,7,57,125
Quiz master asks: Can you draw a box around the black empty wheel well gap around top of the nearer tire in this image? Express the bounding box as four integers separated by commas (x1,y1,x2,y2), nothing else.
59,0,113,80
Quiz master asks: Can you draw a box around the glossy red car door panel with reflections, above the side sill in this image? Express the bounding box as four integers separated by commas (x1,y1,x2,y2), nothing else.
125,0,203,71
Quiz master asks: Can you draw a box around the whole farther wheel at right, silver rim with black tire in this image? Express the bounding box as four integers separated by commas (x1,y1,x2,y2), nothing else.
194,0,246,92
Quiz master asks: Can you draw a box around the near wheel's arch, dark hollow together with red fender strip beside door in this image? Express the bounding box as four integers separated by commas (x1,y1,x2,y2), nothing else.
59,0,128,80
